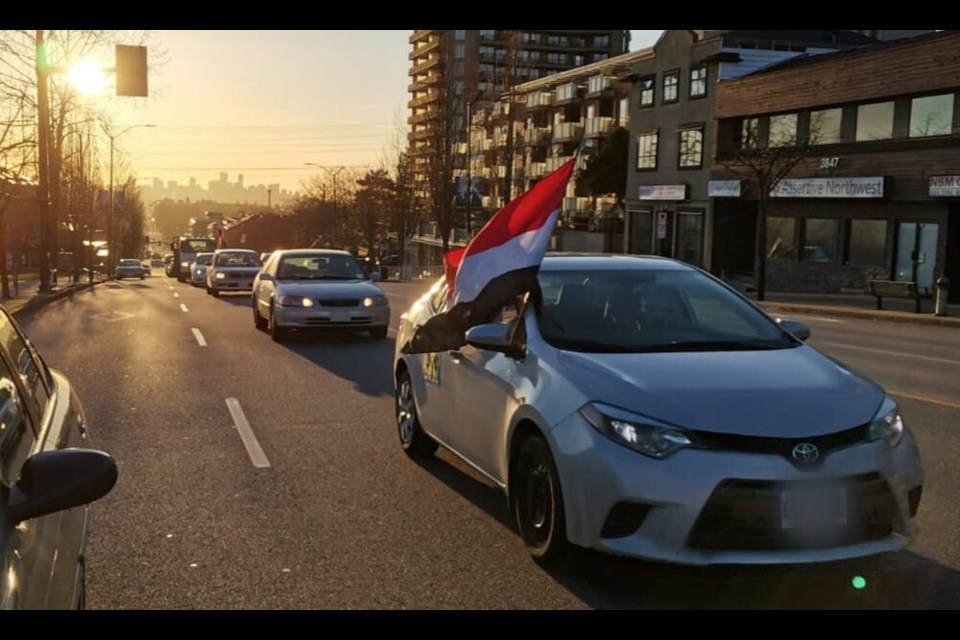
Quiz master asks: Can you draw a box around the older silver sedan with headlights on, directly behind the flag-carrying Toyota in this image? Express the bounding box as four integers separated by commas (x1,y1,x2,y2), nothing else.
253,249,390,342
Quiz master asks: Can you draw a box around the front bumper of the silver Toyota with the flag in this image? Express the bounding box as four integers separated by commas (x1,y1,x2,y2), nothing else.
550,414,923,565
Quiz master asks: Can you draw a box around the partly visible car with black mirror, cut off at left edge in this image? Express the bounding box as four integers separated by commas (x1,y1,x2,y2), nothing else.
0,308,117,609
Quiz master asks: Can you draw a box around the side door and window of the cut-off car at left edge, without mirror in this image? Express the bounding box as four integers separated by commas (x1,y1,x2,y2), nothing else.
0,313,87,609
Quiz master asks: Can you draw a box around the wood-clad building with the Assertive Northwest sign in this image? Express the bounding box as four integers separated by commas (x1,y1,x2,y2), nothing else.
713,31,960,300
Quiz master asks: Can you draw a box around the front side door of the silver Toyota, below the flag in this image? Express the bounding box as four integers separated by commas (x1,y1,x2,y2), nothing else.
445,300,529,482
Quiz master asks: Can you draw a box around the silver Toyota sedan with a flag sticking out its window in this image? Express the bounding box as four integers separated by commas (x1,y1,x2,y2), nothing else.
394,255,923,565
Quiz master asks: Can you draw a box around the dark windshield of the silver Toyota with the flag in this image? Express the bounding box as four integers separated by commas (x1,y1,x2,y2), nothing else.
538,270,801,353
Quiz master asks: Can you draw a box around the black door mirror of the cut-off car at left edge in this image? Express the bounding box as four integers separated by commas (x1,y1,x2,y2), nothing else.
7,449,117,524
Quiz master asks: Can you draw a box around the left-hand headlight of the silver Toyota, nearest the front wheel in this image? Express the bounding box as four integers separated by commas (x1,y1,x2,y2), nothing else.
580,403,696,459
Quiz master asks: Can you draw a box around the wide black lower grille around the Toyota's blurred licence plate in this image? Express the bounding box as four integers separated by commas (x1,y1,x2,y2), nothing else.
687,473,896,551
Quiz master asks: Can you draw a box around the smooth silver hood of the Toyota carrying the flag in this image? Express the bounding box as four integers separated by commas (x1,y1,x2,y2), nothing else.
559,345,885,438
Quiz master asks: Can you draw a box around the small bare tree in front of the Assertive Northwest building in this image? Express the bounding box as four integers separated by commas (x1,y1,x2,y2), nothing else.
716,114,823,301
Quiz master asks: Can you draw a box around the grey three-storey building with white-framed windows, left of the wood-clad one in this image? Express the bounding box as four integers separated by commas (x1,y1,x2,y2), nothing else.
619,30,876,268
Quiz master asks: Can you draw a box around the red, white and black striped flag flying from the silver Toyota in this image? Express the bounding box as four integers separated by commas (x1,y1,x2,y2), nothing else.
402,155,577,353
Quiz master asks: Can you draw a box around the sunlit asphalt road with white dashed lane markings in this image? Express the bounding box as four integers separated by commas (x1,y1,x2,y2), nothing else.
16,270,960,609
